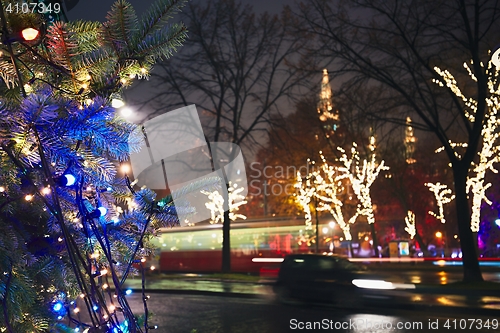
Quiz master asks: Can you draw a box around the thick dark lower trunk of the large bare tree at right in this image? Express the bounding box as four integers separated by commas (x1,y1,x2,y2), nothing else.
453,163,483,282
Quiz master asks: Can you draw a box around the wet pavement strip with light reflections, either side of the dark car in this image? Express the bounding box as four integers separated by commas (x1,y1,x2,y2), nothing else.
120,275,500,317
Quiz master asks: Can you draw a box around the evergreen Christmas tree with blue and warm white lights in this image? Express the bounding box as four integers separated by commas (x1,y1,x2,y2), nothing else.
0,0,191,333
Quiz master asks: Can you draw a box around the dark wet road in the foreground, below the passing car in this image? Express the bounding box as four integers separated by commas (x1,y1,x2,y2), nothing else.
124,294,500,333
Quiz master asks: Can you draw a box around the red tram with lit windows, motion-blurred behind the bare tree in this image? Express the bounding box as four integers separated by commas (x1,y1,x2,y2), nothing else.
151,219,340,273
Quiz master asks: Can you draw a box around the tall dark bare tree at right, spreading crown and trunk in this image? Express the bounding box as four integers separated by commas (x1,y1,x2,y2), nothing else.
297,0,500,281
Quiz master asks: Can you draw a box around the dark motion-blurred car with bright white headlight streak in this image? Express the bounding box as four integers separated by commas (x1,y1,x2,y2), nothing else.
273,254,410,308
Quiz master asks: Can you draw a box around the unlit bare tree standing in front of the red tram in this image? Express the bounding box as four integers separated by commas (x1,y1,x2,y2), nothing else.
139,0,310,272
